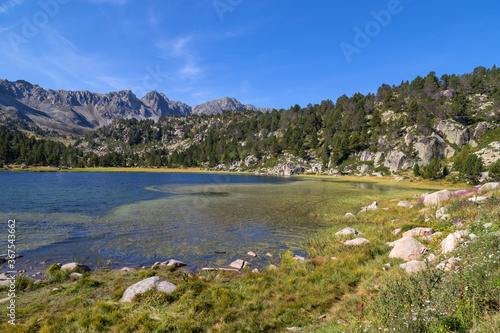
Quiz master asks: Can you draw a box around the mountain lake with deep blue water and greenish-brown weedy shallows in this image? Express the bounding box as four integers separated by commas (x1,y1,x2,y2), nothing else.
0,172,406,271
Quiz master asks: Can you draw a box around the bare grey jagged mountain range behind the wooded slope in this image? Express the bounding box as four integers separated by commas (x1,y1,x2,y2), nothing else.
0,79,272,135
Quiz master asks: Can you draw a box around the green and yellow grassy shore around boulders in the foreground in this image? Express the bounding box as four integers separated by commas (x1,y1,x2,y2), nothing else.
0,177,500,332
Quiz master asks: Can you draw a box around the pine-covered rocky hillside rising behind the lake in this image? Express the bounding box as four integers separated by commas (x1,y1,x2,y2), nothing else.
2,66,500,176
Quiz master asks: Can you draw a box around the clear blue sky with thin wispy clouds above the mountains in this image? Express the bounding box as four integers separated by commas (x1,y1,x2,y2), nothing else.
0,0,500,109
